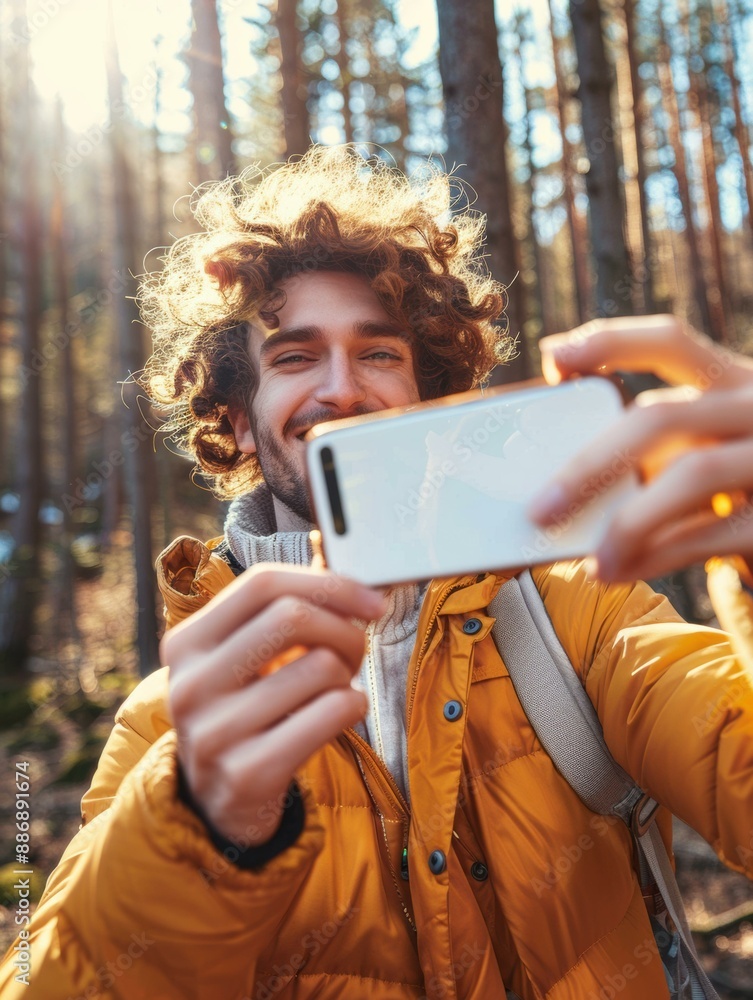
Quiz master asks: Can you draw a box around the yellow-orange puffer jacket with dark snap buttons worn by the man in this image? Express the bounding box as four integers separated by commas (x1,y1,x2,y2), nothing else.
0,539,753,1000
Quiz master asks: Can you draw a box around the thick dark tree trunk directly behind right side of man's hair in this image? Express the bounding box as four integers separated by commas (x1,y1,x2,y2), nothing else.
437,0,531,382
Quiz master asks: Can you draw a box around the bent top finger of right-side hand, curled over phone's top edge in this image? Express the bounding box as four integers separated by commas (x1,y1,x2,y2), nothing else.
539,315,753,391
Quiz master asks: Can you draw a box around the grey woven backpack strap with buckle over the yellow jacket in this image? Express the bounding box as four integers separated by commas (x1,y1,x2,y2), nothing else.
488,570,718,1000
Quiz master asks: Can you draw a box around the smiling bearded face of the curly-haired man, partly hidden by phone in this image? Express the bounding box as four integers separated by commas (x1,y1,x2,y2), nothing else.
236,271,419,521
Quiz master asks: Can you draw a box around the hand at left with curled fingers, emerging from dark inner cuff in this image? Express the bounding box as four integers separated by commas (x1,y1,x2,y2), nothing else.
161,564,385,845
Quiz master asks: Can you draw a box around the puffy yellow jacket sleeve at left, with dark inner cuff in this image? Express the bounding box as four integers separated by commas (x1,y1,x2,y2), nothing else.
0,672,323,1000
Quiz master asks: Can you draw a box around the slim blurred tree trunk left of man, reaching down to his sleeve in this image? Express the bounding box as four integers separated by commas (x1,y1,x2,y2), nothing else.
107,4,159,675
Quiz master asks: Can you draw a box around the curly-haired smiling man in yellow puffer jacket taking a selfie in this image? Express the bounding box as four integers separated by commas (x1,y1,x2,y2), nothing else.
3,150,753,1000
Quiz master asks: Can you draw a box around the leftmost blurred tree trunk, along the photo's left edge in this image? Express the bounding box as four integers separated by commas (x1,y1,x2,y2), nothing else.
0,0,42,667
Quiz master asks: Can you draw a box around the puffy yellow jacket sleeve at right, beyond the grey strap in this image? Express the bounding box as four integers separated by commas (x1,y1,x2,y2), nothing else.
535,564,753,877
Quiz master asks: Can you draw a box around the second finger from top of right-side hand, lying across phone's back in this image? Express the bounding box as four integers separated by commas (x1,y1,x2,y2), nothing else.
528,388,753,524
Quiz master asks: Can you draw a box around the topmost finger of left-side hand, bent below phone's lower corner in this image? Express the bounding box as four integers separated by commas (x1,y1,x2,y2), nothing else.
162,564,385,665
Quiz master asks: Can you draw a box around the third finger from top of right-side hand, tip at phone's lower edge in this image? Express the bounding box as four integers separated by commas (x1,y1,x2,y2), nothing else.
596,440,753,573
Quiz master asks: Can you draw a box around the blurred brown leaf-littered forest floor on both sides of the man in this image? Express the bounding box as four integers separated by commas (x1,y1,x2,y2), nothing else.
0,532,753,1000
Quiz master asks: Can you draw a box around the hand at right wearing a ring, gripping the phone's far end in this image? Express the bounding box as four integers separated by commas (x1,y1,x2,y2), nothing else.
530,316,753,580
